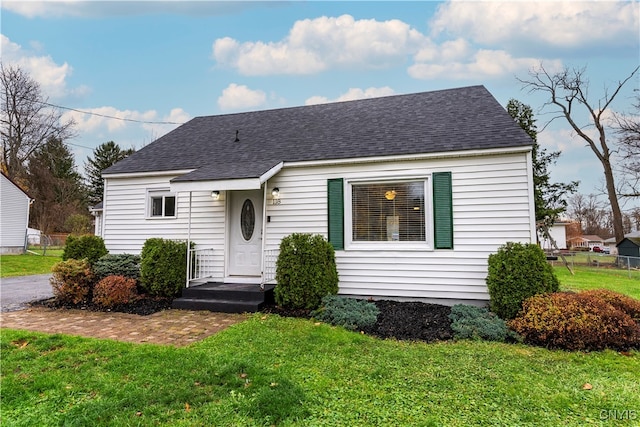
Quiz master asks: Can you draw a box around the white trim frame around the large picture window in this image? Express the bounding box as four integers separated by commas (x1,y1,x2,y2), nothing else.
344,175,434,251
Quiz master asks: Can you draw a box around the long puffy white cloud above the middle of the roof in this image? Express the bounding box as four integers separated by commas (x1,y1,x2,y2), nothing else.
213,15,426,75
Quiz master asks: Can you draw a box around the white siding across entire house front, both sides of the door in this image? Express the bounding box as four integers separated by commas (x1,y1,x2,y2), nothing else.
104,152,535,301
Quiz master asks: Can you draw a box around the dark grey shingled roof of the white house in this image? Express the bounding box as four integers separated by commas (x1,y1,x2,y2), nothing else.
104,86,533,181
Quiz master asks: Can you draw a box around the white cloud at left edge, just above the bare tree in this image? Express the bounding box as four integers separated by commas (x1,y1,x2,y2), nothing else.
0,34,73,98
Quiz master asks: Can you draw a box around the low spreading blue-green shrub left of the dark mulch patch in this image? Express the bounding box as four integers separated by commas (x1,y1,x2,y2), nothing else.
312,295,380,331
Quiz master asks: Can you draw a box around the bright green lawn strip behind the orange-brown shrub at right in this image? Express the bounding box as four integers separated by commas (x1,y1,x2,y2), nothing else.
554,263,640,299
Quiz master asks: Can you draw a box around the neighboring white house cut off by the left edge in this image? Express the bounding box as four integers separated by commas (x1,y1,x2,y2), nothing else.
0,173,31,254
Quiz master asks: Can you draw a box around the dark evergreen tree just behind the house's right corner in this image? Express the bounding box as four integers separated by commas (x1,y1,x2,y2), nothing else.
507,99,579,225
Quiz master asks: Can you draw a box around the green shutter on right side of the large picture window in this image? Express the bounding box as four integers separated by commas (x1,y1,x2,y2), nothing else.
433,172,453,249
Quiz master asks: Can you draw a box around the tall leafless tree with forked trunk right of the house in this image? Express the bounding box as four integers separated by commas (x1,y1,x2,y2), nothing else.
519,64,640,241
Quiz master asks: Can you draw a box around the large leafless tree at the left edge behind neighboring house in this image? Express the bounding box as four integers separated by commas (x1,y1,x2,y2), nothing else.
0,64,74,182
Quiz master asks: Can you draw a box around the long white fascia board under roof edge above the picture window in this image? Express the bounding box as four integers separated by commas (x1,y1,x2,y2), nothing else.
285,146,533,168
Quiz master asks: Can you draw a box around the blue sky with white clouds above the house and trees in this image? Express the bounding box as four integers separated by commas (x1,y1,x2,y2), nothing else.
0,0,640,211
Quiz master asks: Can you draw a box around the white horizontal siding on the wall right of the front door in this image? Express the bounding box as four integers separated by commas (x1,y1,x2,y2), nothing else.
266,153,535,300
